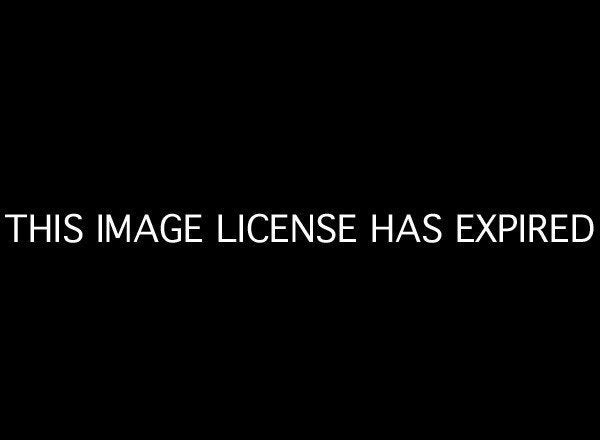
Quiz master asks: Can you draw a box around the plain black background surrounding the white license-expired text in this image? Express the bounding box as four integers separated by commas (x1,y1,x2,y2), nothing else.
1,5,598,433
